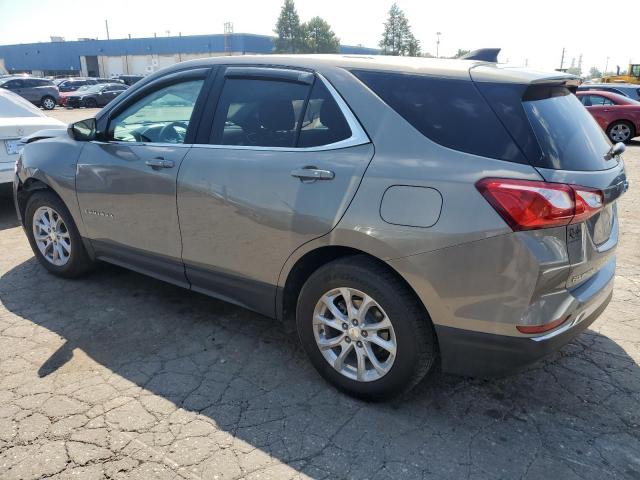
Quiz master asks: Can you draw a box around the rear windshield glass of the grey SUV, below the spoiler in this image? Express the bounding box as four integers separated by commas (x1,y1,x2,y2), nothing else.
522,87,614,170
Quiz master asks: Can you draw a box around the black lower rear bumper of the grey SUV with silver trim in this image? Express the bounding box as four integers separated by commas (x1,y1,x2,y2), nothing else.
436,279,613,378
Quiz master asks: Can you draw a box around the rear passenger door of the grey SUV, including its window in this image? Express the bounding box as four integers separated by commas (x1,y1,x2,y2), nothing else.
178,67,373,315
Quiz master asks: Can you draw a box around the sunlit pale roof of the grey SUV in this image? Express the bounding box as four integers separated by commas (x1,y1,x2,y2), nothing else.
152,54,577,83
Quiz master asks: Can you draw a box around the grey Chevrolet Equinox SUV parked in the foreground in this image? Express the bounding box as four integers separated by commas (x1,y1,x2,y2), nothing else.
14,55,627,399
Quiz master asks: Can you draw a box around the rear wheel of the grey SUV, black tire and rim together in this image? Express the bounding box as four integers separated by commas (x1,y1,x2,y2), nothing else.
296,256,437,400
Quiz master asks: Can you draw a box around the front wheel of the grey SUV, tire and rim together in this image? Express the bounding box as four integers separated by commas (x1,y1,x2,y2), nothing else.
24,191,94,278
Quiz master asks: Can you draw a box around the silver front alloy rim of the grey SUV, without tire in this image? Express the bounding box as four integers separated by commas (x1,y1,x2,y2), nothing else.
33,206,71,267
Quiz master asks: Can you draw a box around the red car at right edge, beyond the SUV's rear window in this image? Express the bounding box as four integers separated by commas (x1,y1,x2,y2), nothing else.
576,90,640,143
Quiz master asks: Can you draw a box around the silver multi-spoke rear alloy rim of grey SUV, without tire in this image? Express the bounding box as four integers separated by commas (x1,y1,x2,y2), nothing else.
313,287,397,382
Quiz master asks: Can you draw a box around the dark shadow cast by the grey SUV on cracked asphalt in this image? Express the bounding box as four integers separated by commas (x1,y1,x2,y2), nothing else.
0,253,640,479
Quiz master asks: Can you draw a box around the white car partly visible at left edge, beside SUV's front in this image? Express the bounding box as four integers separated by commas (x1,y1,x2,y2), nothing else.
0,90,66,184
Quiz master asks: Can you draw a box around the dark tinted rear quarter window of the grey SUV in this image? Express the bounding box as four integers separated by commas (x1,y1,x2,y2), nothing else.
352,70,527,163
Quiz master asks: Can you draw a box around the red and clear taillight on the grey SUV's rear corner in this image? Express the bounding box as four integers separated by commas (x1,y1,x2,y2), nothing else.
476,178,604,230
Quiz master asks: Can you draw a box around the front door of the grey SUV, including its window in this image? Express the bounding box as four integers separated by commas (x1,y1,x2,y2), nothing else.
76,78,204,286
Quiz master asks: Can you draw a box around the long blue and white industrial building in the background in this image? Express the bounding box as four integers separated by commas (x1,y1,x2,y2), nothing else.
0,33,379,77
